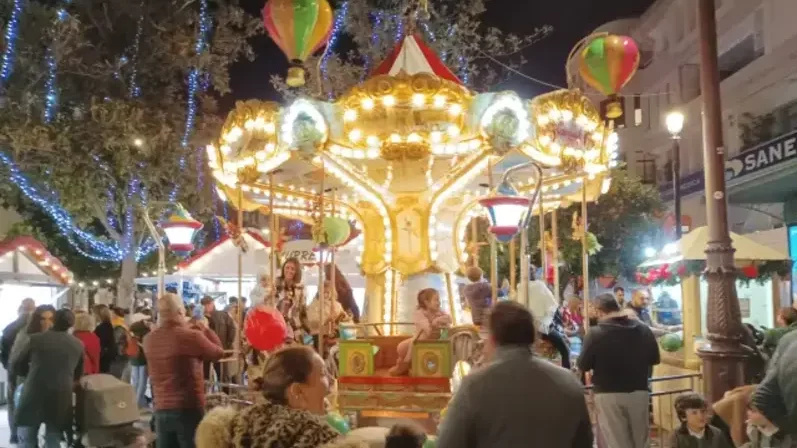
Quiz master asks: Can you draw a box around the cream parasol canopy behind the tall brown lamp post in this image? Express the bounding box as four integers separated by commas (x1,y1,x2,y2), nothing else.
642,227,789,267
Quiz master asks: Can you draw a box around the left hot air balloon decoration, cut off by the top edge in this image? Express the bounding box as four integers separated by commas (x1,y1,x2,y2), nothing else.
263,0,333,87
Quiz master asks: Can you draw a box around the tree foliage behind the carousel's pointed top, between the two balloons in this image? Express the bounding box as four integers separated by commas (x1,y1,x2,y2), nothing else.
272,0,552,98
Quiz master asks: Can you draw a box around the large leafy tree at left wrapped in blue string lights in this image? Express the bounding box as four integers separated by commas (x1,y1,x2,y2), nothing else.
0,0,261,302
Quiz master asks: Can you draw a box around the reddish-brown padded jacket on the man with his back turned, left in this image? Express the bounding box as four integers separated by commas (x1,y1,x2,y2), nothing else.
144,322,224,411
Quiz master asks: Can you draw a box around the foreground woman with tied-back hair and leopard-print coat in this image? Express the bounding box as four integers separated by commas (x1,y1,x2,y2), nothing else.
196,346,342,448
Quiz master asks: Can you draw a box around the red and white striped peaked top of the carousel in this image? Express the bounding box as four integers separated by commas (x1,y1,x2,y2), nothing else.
372,35,462,85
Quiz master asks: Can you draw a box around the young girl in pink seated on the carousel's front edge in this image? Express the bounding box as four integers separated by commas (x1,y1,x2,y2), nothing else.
390,288,451,376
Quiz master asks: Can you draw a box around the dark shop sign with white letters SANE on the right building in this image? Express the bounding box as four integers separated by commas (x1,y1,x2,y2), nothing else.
725,131,797,180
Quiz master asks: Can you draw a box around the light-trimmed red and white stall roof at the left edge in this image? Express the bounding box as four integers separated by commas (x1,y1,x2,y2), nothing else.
0,236,73,285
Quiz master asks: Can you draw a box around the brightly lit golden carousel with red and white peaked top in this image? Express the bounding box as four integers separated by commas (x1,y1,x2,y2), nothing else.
207,0,639,431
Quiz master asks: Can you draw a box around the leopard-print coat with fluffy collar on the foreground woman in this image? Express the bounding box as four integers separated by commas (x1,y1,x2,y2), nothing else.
195,402,342,448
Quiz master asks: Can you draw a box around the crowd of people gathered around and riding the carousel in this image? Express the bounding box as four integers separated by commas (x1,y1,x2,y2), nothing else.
7,259,797,448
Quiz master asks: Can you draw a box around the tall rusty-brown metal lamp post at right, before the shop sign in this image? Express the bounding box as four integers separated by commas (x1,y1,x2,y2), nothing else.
697,0,748,402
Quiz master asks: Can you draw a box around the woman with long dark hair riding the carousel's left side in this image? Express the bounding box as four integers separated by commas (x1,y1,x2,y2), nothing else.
274,257,310,343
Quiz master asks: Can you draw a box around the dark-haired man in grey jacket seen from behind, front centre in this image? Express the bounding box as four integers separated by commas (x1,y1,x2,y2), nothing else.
437,302,592,448
